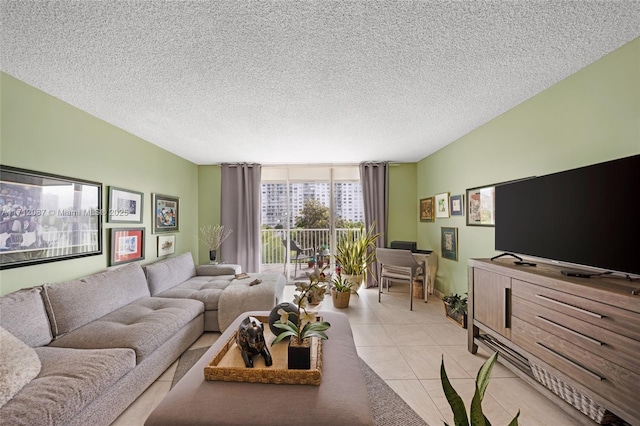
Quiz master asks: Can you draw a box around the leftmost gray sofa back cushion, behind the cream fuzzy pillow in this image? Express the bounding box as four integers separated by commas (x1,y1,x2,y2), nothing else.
0,287,53,347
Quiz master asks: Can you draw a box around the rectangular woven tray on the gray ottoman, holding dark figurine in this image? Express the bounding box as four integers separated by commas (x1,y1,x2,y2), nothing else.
204,316,322,386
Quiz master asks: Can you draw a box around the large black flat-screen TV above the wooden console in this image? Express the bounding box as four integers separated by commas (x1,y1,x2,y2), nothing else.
495,155,640,274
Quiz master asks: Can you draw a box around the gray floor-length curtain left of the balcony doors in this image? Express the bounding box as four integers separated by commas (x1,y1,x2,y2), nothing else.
220,163,262,272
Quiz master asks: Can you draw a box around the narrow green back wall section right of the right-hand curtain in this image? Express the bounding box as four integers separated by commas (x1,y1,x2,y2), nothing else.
387,163,422,248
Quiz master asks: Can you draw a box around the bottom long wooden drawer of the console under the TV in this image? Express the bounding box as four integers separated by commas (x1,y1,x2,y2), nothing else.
511,317,640,416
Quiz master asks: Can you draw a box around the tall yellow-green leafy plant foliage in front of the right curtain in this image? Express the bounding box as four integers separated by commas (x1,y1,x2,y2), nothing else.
335,222,382,292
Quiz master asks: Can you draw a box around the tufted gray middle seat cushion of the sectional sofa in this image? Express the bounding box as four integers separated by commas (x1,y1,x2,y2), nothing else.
50,297,204,364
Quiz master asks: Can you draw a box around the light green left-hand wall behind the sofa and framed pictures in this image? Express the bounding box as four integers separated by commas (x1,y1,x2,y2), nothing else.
0,73,198,294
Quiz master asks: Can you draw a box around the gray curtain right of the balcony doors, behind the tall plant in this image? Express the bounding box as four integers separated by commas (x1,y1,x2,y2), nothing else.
360,162,389,287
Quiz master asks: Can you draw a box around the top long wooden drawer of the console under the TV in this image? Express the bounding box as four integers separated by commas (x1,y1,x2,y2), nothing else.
511,279,640,341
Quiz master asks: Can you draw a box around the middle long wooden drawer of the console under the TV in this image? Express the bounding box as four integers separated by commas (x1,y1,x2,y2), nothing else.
512,297,640,374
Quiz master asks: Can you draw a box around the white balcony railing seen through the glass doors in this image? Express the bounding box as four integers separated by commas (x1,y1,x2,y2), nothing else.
261,228,359,265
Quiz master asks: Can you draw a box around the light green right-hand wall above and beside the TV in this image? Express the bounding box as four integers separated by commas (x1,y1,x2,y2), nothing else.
417,39,640,293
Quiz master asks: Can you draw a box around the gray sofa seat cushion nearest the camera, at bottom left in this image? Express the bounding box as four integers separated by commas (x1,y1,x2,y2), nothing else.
0,347,136,426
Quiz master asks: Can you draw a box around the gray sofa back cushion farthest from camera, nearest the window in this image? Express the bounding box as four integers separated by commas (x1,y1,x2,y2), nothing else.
144,253,196,296
